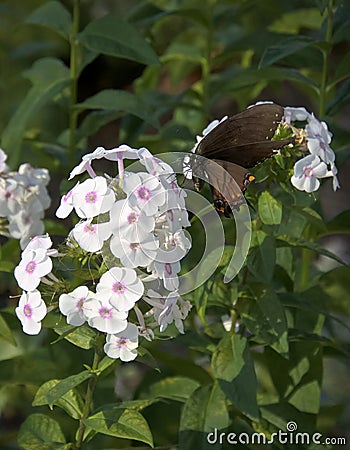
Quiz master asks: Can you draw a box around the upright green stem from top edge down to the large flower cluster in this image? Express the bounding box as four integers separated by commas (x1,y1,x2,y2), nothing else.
69,0,80,167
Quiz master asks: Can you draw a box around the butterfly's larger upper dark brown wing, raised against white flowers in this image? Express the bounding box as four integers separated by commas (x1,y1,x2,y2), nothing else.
196,103,293,167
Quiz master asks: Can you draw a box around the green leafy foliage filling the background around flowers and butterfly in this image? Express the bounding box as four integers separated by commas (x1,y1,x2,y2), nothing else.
0,0,350,450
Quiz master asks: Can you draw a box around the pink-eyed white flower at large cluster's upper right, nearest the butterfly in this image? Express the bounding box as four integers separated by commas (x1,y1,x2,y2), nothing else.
123,172,166,216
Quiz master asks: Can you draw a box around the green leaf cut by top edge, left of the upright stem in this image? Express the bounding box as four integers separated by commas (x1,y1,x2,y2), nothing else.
26,1,72,40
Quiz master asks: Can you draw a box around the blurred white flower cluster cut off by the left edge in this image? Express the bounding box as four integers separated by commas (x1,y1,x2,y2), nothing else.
0,149,51,249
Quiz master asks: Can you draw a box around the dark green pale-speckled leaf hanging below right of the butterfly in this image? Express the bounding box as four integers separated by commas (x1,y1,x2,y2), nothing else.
237,284,288,354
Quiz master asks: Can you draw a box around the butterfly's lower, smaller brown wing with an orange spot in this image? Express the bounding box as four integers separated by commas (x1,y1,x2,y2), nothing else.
207,160,254,217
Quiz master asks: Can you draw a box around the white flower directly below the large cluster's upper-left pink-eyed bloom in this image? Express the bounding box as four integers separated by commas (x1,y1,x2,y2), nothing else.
72,219,111,252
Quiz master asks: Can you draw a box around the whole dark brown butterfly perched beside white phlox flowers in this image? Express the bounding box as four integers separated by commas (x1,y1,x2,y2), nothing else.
190,103,294,217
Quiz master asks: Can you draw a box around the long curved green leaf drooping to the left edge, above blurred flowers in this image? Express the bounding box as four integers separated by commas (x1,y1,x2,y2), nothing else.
1,58,70,166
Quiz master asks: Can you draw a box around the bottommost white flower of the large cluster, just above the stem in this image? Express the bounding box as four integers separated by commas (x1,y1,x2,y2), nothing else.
104,323,139,362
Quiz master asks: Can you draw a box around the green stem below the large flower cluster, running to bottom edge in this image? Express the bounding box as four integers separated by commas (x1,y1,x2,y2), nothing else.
75,334,104,450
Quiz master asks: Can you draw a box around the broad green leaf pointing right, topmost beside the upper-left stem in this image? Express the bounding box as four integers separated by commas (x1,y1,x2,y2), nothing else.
78,14,159,65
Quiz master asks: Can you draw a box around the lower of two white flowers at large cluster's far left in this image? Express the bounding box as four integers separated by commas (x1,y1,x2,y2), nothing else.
16,290,47,335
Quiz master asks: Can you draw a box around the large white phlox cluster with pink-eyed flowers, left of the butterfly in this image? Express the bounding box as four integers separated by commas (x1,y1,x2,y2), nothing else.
15,145,191,361
